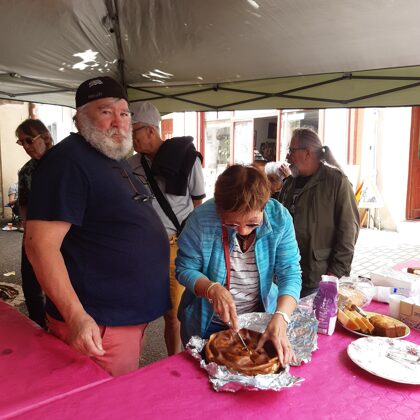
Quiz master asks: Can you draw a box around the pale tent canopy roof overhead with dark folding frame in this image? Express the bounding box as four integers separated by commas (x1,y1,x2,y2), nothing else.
0,0,420,112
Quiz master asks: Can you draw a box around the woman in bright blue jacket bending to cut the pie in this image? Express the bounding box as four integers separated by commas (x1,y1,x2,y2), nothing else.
176,165,301,364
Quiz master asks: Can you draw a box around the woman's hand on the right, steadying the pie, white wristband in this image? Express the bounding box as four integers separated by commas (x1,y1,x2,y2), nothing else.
257,314,296,366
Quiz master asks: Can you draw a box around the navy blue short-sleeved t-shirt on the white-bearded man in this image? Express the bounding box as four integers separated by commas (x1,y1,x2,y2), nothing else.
28,134,170,326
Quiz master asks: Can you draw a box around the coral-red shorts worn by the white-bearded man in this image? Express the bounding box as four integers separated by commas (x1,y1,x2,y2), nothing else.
47,315,147,376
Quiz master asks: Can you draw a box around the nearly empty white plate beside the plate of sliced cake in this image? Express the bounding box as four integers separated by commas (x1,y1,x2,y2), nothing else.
347,337,420,385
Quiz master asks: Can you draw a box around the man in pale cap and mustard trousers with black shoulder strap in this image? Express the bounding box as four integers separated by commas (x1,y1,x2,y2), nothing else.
128,102,206,356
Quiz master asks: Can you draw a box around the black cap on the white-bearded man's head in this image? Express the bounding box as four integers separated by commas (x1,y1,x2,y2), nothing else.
76,76,128,108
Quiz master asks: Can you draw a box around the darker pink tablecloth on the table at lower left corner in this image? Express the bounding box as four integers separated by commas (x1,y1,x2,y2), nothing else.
0,300,111,418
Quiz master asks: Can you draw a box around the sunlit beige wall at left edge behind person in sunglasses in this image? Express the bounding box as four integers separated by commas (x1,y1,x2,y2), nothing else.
0,101,29,217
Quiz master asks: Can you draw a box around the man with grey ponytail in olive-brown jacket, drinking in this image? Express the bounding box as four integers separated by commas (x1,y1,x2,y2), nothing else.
279,128,360,297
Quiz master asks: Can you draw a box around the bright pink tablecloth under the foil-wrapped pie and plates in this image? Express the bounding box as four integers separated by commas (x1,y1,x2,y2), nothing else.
13,303,420,420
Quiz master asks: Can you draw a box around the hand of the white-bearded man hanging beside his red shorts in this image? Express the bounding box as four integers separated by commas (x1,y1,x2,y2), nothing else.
67,312,105,356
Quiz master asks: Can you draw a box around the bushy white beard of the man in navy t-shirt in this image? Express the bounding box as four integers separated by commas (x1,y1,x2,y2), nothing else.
78,114,133,160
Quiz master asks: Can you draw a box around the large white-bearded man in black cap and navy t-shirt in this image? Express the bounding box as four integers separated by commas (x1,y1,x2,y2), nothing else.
25,77,170,376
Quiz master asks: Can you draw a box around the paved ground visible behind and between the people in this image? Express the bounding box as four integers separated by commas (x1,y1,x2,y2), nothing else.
0,220,420,365
